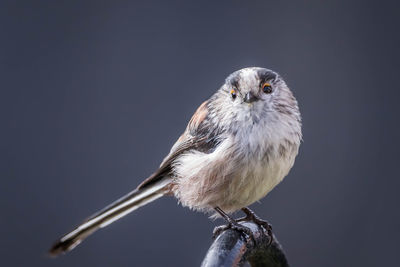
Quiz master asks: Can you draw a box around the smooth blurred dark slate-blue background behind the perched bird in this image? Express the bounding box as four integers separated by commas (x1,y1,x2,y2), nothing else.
0,1,400,266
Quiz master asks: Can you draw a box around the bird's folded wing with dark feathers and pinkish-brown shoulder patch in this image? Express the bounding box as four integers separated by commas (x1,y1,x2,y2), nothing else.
138,101,220,189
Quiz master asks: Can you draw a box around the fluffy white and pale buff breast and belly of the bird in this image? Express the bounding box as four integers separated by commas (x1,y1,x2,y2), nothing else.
174,114,298,215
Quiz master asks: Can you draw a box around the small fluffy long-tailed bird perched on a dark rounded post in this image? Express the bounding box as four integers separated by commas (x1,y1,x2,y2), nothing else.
49,67,302,256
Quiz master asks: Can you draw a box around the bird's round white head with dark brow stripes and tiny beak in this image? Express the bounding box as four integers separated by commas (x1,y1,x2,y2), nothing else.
212,67,300,130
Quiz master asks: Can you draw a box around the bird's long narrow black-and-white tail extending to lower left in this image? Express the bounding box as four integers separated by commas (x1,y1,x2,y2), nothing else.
49,178,171,256
